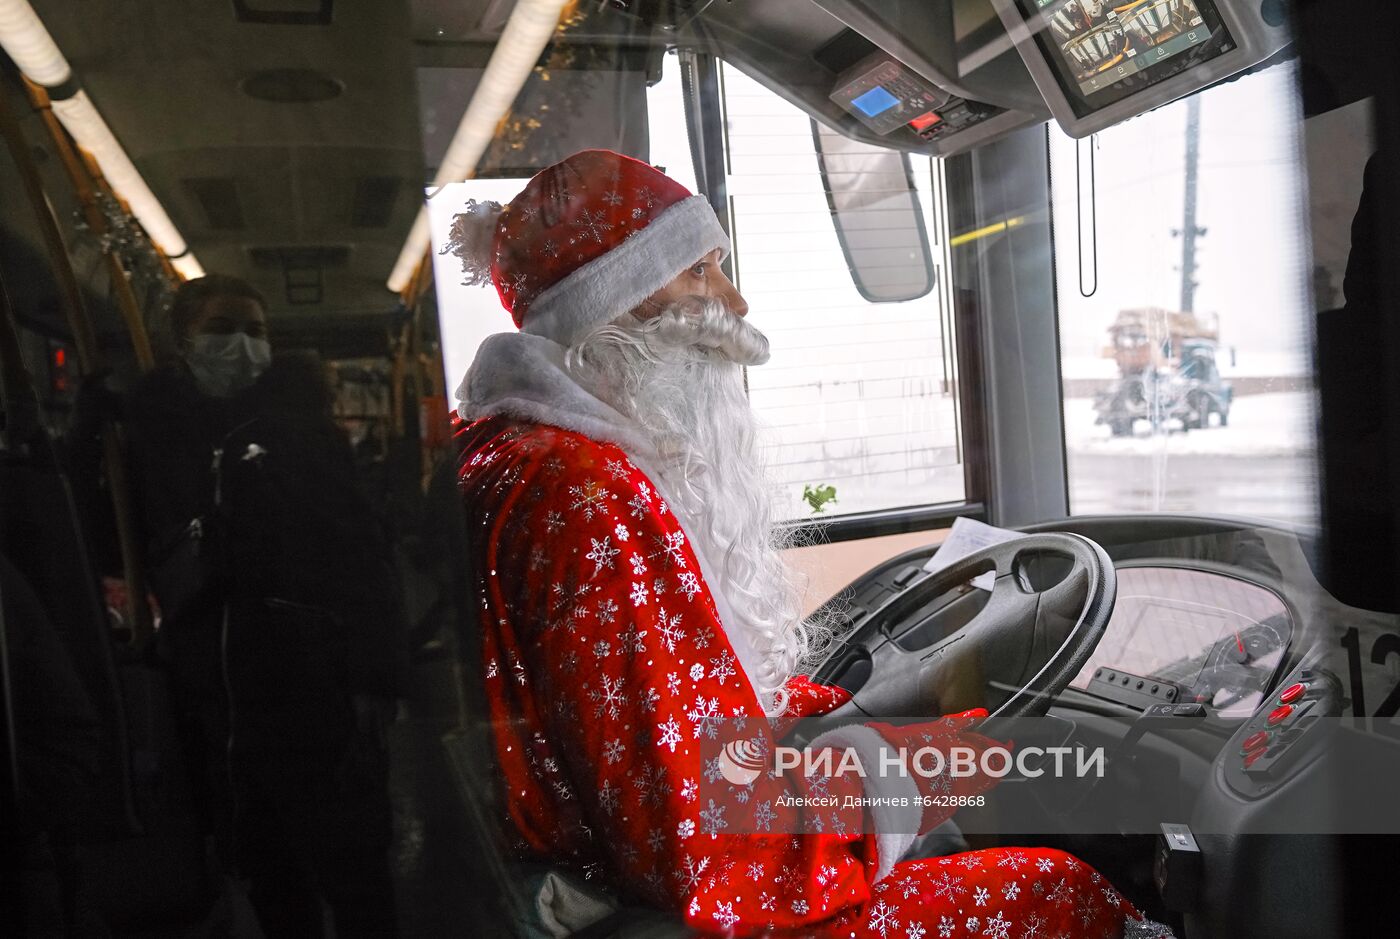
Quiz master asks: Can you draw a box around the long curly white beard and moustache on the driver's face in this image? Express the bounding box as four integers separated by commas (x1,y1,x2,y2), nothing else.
566,298,826,715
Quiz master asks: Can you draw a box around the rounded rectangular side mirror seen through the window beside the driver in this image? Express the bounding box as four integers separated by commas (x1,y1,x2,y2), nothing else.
812,120,934,304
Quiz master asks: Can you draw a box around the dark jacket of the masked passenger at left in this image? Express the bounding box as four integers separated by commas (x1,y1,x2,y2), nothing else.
125,352,405,733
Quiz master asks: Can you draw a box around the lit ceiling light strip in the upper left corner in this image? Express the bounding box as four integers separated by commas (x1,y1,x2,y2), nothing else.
0,0,204,280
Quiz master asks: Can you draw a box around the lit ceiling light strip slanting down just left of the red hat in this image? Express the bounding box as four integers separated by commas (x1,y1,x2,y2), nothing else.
389,0,568,292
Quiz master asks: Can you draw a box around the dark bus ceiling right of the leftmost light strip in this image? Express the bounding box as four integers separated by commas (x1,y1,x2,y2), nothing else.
25,0,423,345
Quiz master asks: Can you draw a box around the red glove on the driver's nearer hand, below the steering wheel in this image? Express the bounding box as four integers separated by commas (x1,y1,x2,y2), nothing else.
867,708,1012,834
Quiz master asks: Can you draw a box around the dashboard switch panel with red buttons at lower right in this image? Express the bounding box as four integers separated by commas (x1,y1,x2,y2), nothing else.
1225,668,1343,796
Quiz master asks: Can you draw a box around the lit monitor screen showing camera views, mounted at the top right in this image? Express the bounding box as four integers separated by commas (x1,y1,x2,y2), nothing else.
1019,0,1233,116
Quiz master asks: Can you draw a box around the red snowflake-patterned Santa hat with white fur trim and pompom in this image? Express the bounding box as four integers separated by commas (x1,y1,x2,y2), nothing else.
442,150,729,346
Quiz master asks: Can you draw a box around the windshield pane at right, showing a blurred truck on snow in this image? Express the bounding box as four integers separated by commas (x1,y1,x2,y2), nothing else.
1050,66,1319,526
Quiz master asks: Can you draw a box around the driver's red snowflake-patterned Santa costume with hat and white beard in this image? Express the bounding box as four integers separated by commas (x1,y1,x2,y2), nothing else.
448,151,1170,939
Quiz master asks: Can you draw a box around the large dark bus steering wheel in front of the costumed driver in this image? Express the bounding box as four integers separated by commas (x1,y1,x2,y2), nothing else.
804,533,1117,736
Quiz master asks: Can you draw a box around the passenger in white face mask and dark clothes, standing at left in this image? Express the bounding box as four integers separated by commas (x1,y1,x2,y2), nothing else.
80,274,402,939
